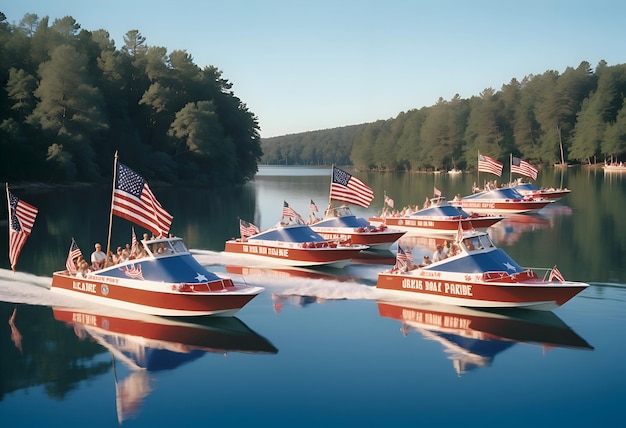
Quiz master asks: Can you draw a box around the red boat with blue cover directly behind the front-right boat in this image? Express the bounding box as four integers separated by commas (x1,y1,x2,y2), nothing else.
369,197,504,235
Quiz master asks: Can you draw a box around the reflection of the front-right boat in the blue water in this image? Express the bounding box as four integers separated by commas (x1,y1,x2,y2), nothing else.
378,302,593,376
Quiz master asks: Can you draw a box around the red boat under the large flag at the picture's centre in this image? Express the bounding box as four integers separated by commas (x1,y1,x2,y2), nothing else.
309,204,406,251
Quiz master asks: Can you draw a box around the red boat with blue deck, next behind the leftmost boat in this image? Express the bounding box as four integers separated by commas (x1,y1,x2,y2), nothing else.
224,202,368,268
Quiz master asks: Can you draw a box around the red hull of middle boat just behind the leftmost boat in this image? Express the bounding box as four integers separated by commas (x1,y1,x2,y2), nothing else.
224,239,367,268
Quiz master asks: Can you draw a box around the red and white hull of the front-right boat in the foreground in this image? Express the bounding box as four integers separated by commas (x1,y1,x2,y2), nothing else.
376,269,588,310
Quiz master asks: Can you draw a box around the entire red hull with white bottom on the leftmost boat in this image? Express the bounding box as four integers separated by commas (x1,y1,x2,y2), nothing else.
50,271,263,316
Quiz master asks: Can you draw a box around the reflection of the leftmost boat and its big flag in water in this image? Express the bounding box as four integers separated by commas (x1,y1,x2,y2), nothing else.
53,308,278,424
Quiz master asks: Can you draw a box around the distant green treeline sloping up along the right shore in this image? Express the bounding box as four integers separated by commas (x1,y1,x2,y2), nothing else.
262,61,626,171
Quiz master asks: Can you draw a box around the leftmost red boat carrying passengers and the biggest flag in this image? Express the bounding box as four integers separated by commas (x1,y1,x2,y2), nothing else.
50,154,263,316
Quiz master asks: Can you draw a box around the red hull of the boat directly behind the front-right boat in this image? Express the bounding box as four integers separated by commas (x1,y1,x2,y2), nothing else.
369,216,504,235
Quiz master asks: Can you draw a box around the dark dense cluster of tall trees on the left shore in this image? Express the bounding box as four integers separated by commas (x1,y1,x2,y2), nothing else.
0,12,262,186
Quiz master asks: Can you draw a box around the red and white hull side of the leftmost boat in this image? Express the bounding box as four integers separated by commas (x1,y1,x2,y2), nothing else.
51,272,262,316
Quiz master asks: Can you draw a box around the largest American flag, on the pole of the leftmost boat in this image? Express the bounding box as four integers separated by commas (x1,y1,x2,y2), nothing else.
113,162,173,236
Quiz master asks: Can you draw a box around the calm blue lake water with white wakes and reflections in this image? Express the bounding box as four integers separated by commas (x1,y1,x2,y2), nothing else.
0,166,626,427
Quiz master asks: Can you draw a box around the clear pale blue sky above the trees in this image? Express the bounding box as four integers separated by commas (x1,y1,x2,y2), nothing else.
0,0,626,137
